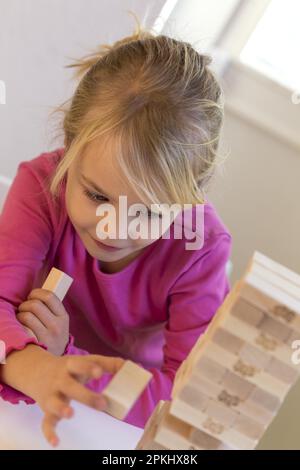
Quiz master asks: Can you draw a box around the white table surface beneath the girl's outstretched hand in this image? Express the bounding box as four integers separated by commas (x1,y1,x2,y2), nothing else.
0,398,143,450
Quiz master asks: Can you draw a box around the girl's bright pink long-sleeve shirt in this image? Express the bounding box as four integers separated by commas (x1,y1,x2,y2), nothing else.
0,148,232,427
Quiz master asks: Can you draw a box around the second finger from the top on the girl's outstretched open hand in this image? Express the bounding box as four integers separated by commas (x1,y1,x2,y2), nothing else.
61,376,107,411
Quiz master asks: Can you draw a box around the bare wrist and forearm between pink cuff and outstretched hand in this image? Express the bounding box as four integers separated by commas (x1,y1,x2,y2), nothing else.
0,344,53,398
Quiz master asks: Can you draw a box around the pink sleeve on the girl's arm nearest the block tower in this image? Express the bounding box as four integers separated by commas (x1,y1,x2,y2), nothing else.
71,233,231,427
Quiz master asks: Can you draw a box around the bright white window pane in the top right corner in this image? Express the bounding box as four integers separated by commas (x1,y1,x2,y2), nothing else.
240,0,300,90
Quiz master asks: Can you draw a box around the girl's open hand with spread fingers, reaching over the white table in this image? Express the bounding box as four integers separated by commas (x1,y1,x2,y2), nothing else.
31,354,125,446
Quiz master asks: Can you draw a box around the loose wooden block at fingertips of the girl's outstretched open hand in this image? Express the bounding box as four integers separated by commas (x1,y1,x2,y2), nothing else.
102,361,152,420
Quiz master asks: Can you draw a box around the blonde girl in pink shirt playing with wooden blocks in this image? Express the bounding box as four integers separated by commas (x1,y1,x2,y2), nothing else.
0,22,231,445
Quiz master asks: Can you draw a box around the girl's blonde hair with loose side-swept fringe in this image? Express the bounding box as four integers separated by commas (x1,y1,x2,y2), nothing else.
50,12,223,204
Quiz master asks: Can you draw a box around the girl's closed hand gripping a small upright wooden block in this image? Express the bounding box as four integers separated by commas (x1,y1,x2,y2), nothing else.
17,289,69,356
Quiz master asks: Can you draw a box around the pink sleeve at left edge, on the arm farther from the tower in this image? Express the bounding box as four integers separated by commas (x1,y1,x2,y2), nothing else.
0,162,54,403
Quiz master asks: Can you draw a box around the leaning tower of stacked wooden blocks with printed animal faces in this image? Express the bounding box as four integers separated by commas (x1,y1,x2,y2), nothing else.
137,252,300,450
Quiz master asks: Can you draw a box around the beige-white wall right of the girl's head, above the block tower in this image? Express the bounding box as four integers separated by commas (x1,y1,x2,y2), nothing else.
210,62,300,280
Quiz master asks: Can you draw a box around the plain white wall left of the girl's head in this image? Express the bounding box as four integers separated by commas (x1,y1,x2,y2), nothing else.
0,0,165,177
